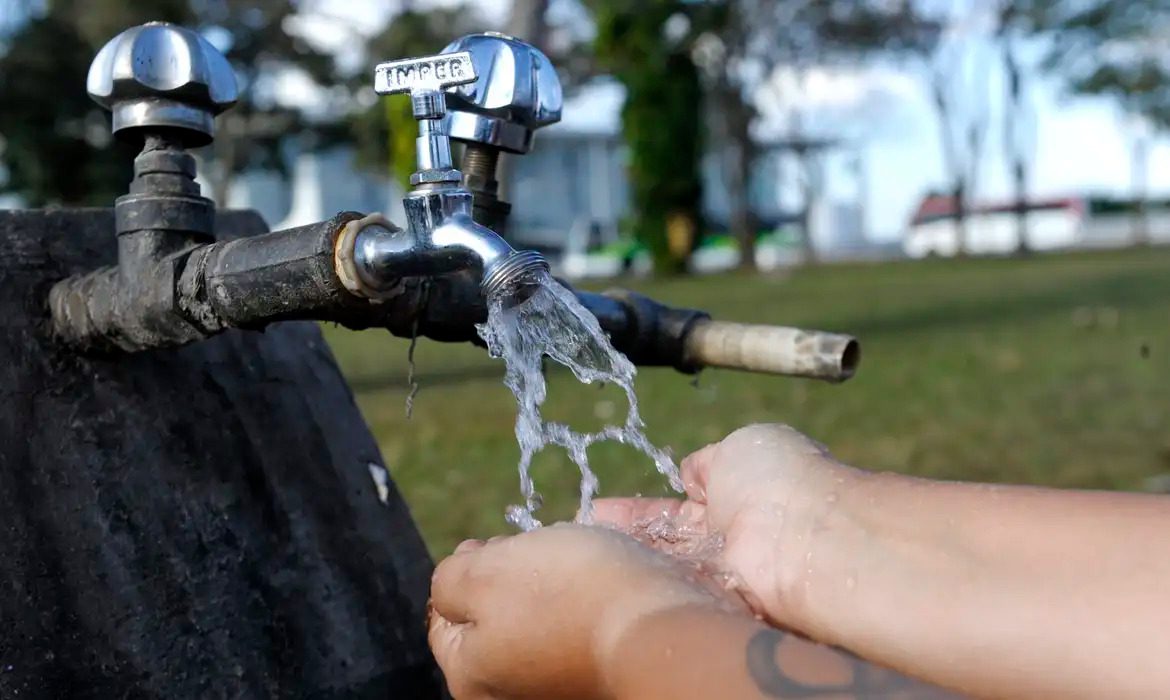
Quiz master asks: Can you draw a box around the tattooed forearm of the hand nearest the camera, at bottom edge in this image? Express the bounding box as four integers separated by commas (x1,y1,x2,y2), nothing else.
607,608,948,700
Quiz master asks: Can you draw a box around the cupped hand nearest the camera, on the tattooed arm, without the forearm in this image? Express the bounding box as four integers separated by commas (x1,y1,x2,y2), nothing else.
429,524,727,700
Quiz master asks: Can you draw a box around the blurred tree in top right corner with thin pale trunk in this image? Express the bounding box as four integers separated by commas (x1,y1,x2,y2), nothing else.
1034,0,1170,242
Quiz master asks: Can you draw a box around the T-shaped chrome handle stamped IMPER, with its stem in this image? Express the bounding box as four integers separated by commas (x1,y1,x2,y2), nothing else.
373,52,477,185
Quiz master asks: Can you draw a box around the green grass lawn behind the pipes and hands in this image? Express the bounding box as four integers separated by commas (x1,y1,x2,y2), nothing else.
326,248,1170,555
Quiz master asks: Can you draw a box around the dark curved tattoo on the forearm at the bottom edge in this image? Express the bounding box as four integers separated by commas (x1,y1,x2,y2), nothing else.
745,629,954,700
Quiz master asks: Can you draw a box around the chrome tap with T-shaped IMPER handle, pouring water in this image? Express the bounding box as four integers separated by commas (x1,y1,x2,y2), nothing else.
338,52,549,298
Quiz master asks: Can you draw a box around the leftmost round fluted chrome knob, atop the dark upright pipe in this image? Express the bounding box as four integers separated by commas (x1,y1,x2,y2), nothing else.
85,22,238,146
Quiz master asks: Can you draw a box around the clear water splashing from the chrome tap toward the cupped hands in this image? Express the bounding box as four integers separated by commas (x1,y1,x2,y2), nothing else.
476,273,682,530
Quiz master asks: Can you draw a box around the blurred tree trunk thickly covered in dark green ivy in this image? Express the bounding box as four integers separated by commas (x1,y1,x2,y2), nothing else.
586,0,703,273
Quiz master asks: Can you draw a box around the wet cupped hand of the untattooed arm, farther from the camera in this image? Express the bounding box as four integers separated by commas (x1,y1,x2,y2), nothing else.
593,425,861,629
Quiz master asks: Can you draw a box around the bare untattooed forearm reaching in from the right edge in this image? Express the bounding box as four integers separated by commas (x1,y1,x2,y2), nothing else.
787,475,1170,698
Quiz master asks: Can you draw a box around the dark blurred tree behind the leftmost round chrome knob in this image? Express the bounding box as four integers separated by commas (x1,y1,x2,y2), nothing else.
0,0,344,206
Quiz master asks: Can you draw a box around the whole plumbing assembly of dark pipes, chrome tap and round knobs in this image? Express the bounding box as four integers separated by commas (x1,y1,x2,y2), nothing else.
48,22,859,382
